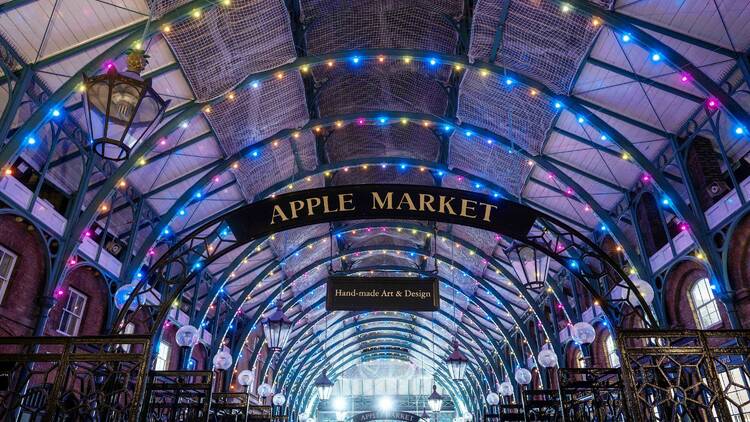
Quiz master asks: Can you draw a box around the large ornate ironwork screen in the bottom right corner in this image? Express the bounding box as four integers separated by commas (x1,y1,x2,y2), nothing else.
618,330,750,421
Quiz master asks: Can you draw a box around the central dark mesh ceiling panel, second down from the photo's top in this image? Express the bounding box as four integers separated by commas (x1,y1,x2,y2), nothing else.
314,61,449,116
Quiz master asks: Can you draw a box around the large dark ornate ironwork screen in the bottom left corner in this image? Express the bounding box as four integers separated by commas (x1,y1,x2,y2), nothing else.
0,336,151,422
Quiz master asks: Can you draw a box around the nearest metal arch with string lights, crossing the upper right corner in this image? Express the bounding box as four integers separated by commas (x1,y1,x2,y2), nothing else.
556,0,750,127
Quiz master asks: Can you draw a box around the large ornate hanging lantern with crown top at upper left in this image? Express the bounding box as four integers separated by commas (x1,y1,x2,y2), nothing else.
83,49,169,161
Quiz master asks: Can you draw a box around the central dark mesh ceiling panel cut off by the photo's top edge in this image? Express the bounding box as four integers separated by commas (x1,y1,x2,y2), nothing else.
301,0,461,55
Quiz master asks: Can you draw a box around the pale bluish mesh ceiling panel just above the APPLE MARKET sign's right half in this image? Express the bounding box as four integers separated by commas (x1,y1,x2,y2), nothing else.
448,132,532,195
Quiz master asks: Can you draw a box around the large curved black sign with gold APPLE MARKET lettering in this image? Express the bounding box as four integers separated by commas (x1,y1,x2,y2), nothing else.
225,185,538,242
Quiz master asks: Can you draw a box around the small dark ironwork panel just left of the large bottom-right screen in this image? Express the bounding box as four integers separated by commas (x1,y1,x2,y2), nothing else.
558,368,631,421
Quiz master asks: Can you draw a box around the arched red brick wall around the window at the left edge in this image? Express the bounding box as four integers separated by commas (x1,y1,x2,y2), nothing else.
0,215,46,336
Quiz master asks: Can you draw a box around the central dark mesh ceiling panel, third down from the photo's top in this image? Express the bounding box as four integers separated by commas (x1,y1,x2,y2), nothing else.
325,124,440,163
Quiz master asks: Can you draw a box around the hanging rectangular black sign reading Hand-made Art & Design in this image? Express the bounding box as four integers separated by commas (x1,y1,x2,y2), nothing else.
326,276,440,311
